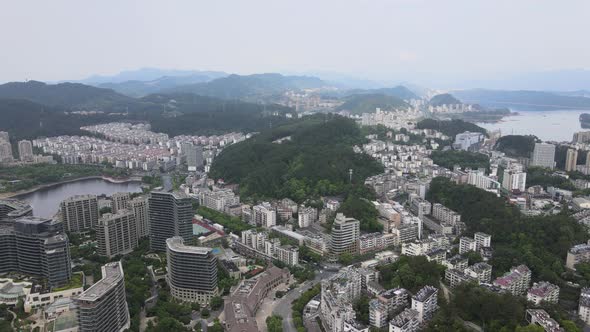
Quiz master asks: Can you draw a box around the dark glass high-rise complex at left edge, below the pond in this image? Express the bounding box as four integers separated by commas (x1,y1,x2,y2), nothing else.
0,217,72,287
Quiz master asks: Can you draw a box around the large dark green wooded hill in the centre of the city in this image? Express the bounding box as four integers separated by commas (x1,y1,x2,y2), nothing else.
209,115,383,202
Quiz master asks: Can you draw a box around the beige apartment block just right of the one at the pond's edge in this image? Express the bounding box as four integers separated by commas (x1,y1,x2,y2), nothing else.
96,210,137,257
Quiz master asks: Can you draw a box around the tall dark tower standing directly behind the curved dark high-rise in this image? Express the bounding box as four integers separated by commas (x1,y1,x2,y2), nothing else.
148,191,193,251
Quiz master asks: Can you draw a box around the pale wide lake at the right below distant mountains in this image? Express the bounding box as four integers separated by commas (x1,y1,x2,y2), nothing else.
477,110,590,142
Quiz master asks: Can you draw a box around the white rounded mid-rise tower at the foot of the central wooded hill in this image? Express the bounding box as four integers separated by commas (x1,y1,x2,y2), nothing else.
330,213,360,256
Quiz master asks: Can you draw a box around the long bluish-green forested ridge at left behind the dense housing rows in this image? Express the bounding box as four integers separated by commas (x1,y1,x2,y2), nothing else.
0,82,298,140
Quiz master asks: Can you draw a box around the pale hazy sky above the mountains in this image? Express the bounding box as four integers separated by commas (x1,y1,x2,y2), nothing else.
0,0,590,85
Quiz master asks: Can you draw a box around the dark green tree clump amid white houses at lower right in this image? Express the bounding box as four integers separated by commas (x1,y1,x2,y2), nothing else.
378,256,445,293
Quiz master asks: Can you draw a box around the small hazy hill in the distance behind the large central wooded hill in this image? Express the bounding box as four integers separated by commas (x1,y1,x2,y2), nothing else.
336,94,409,114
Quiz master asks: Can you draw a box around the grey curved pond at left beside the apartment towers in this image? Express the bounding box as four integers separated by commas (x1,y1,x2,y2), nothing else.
18,179,141,218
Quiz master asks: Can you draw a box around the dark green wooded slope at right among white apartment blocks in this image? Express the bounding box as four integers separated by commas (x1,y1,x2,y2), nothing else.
427,177,588,285
